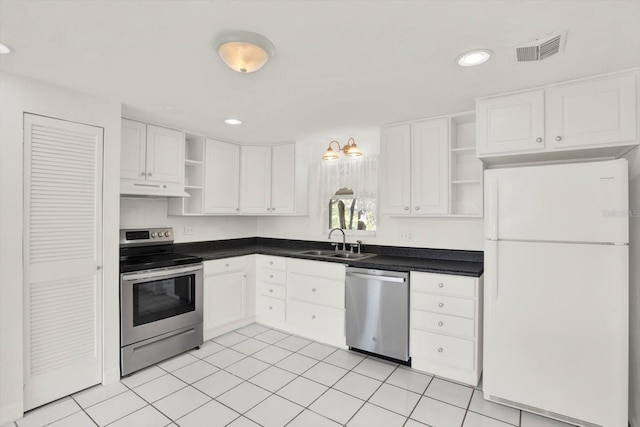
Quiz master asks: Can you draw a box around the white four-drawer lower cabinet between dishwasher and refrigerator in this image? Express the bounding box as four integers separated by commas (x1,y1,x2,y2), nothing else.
409,271,483,386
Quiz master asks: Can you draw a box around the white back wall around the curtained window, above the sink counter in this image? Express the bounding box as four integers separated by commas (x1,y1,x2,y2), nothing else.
257,128,483,250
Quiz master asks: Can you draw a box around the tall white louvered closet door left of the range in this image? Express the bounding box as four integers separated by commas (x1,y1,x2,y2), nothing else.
24,114,103,410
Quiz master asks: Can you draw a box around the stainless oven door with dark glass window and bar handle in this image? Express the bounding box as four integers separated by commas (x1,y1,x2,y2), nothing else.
120,264,202,346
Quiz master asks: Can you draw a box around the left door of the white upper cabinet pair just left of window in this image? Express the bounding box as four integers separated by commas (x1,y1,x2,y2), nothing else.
240,146,271,215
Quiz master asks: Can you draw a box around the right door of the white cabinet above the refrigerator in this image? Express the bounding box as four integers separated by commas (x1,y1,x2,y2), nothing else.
547,73,638,149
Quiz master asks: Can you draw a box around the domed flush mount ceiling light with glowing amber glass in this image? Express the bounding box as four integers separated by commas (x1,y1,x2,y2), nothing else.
214,30,276,73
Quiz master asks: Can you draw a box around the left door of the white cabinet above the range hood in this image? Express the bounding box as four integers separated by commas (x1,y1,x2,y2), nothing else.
120,119,147,181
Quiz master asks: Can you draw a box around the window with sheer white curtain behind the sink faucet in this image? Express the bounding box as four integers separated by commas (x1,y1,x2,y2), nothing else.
320,157,378,234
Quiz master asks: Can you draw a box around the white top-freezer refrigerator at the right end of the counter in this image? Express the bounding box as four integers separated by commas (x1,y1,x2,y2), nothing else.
483,160,629,427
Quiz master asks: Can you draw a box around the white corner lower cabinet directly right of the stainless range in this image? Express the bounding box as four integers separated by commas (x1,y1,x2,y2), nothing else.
203,256,255,340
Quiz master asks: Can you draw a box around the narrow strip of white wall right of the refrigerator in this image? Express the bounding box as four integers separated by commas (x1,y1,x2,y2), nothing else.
627,148,640,427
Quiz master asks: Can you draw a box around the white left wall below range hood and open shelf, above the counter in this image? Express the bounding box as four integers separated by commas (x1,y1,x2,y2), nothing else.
120,197,257,243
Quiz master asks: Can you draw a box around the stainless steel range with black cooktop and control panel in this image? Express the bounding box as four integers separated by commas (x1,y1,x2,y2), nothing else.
120,228,203,376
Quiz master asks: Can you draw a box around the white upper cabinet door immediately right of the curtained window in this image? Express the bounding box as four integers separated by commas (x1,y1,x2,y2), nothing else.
380,124,411,215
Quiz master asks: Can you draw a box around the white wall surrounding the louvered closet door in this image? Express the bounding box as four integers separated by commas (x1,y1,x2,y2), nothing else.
0,73,121,425
